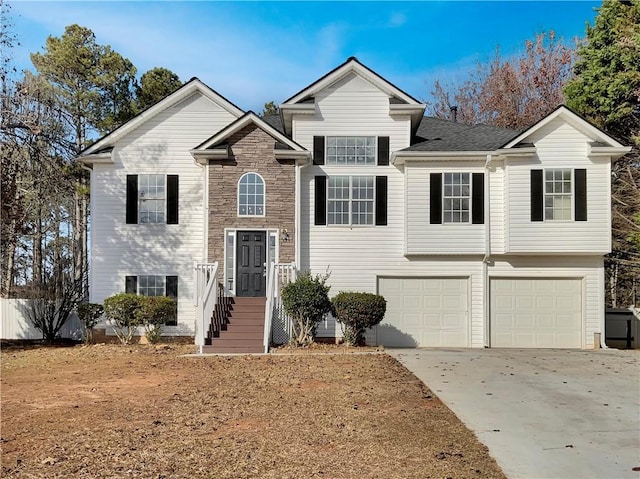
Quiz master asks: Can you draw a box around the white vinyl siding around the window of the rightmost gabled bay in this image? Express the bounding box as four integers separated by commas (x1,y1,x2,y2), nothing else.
506,118,611,254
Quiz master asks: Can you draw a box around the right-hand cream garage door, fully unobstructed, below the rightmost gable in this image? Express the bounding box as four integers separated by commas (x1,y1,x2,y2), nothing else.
491,278,582,348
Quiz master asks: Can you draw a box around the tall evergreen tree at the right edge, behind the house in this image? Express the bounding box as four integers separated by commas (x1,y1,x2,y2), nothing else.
565,0,640,307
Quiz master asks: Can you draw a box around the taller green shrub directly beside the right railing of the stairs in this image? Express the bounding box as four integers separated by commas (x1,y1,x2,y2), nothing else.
282,271,331,346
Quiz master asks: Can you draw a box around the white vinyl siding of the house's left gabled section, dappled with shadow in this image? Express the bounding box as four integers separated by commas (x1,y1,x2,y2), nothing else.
90,93,235,335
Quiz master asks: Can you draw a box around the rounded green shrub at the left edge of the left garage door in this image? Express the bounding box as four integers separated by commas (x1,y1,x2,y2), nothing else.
331,291,387,346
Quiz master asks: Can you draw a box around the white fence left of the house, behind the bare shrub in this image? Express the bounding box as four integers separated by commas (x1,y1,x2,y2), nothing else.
0,298,82,339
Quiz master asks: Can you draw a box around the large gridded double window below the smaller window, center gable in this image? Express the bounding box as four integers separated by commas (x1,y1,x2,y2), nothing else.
327,176,375,226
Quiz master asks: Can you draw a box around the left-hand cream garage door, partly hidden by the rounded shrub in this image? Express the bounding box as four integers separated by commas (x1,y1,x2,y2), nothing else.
377,278,469,347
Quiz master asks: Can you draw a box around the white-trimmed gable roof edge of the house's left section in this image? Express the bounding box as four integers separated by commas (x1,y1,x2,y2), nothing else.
79,77,244,163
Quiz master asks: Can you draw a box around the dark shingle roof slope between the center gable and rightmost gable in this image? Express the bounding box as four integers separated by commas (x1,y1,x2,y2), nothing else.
402,116,521,151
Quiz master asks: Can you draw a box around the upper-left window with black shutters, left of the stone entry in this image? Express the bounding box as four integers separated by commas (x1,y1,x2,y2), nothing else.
126,174,178,225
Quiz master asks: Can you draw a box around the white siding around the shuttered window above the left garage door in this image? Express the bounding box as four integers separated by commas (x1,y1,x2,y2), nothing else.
404,161,485,255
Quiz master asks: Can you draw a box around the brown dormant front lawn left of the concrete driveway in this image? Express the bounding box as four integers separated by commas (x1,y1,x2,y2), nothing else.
0,345,505,479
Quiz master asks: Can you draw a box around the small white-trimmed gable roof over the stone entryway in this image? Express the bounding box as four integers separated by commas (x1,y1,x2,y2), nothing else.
190,111,311,163
